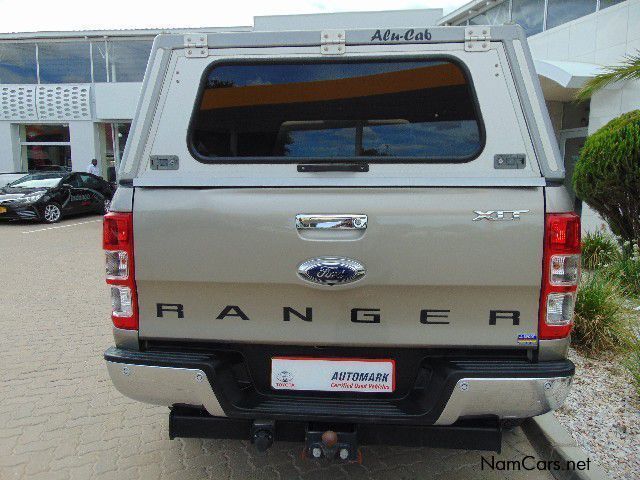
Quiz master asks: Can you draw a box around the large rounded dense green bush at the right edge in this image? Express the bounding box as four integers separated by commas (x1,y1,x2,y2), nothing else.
573,110,640,241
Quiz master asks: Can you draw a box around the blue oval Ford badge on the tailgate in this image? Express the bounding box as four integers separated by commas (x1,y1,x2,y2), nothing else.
298,257,367,287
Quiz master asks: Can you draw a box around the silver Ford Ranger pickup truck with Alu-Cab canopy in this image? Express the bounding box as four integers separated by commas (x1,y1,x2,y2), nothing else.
104,26,580,460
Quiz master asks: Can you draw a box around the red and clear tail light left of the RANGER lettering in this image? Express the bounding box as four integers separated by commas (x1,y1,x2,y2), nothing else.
102,212,138,330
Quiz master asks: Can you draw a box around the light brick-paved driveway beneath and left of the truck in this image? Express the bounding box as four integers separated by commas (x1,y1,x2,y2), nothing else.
0,217,551,480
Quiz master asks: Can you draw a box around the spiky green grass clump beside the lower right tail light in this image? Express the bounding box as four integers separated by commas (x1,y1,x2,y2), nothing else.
572,270,631,354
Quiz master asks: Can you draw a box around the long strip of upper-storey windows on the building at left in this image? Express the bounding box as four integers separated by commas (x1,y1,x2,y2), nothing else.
0,38,153,84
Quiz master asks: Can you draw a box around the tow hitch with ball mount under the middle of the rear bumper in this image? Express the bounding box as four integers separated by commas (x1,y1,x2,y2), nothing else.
303,430,362,462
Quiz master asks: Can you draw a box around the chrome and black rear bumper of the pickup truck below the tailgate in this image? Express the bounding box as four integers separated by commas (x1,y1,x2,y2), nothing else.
105,348,574,425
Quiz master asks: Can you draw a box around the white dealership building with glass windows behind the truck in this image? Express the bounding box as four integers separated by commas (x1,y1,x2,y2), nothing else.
0,0,640,229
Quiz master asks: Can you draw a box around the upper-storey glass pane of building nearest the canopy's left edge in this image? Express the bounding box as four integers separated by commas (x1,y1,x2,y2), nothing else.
109,40,153,82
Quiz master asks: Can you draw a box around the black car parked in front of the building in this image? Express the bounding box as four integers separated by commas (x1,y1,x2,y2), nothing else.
0,172,115,223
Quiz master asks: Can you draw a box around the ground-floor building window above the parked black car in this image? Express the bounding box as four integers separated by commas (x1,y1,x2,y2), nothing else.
20,124,71,172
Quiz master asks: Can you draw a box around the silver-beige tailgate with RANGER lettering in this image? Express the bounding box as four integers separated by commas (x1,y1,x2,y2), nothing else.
134,187,544,348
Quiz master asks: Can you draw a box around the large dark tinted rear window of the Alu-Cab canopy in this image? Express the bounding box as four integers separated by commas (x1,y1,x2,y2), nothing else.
190,60,482,161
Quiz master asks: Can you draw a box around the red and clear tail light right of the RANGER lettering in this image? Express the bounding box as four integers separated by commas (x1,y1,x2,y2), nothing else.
539,213,580,340
